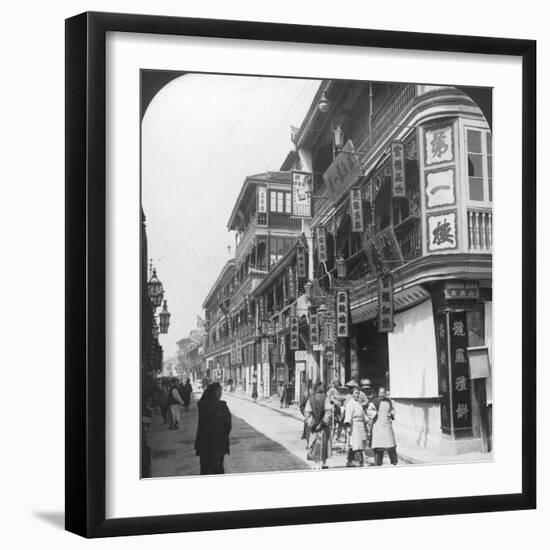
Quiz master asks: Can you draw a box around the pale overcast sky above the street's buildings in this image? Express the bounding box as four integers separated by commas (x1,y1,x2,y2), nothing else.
142,75,319,358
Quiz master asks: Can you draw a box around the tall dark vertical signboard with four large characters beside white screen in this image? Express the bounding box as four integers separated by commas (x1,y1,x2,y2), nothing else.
449,312,472,430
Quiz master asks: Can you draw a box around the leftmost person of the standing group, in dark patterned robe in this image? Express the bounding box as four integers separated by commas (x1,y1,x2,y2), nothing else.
304,382,332,470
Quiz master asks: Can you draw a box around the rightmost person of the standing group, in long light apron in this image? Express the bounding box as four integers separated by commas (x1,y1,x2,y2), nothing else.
367,387,397,466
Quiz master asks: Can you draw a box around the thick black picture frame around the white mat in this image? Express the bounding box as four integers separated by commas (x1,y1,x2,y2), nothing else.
65,13,536,537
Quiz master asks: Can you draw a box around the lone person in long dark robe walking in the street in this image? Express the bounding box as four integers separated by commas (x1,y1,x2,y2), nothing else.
195,382,231,475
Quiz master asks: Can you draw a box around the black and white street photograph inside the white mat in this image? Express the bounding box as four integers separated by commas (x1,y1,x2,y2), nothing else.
141,72,496,483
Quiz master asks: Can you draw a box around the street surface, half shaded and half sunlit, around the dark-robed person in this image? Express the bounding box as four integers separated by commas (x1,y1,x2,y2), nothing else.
149,394,311,477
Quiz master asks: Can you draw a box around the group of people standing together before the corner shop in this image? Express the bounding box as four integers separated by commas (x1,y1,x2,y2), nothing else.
300,380,398,469
